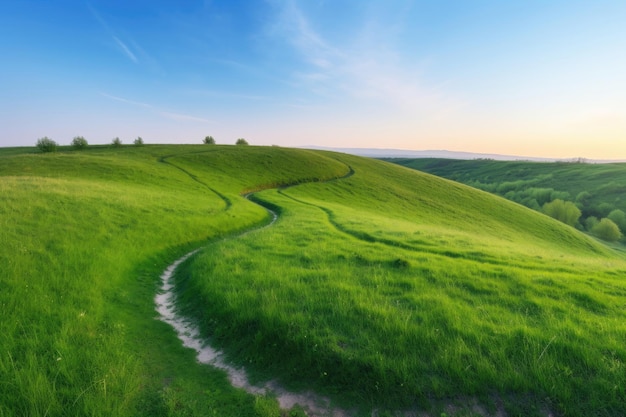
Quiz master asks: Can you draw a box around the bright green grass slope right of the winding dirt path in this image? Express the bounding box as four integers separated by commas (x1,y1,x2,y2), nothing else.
179,156,626,415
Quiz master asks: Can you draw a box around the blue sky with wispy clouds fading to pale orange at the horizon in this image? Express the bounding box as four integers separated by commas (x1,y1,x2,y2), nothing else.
0,0,626,159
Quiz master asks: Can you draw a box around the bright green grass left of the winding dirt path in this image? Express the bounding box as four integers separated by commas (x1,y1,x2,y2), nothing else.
0,146,345,416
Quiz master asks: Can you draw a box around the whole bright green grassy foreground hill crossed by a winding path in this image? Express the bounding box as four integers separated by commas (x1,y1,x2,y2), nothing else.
0,146,626,416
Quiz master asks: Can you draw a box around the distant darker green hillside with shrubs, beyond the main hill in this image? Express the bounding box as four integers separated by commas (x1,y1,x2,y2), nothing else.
388,159,626,240
